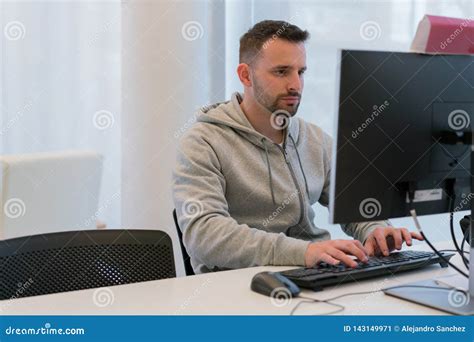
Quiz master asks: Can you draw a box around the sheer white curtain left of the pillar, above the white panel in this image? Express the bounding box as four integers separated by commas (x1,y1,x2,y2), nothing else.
0,1,121,226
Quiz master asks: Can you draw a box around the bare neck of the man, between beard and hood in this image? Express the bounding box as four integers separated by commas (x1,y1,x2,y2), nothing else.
240,96,284,144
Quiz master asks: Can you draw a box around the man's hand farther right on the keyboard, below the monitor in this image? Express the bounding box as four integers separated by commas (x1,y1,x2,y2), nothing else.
364,227,423,256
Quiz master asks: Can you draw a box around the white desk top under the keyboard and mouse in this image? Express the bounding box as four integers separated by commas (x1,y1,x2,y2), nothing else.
0,243,464,315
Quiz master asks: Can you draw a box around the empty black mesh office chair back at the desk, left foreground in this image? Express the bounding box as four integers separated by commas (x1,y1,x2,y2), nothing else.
0,229,176,300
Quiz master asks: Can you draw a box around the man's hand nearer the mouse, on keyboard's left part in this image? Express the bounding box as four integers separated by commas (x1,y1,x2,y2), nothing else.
304,240,368,267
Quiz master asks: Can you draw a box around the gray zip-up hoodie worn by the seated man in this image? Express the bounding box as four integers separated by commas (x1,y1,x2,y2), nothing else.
173,93,389,273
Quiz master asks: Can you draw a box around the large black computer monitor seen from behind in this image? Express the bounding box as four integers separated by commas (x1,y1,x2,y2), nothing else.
330,50,474,314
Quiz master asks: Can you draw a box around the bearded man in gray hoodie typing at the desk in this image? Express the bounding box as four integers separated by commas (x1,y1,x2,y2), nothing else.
173,20,422,273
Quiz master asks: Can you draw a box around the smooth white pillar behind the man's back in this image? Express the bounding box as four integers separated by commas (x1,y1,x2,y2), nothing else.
121,1,225,271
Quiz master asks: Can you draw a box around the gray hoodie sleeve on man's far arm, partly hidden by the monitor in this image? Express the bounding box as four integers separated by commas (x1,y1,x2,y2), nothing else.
319,134,392,243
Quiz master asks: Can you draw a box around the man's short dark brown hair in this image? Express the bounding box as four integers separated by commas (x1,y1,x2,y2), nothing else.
239,20,309,64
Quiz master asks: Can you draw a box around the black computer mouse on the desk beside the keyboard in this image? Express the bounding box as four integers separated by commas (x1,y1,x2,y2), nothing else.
250,272,300,297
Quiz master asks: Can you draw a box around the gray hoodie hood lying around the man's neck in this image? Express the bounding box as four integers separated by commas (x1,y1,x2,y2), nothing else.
197,92,299,149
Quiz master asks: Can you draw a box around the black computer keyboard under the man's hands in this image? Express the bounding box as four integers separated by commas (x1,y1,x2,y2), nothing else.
279,251,454,291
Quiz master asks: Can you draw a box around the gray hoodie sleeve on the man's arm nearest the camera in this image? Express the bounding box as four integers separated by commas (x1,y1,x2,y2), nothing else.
173,132,309,269
